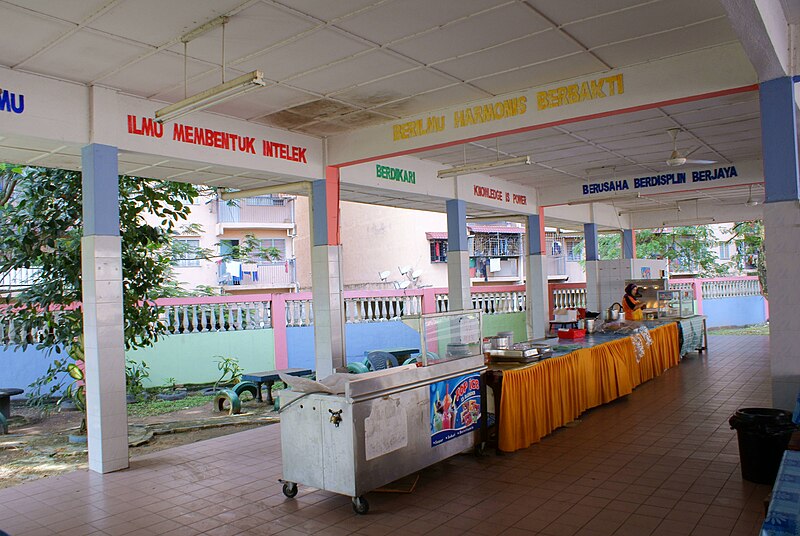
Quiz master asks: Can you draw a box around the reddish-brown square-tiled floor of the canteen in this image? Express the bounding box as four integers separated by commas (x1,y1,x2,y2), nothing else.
0,336,770,536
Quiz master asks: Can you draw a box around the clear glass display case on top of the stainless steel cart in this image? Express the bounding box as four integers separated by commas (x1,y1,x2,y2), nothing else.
414,310,483,366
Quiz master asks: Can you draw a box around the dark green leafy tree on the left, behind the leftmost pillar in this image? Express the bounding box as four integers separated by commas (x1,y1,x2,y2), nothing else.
0,166,197,352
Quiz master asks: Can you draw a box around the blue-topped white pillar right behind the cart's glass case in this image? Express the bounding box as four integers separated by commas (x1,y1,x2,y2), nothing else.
447,199,472,311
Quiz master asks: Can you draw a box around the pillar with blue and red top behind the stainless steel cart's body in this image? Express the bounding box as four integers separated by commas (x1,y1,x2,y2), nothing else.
311,168,347,379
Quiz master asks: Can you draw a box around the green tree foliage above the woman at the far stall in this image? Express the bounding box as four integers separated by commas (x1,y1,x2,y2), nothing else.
636,225,728,277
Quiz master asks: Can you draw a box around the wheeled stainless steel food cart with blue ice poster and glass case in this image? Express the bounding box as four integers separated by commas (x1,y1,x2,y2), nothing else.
280,311,486,514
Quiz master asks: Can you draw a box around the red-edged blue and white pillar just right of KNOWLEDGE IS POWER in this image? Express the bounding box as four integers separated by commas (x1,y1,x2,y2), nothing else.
525,209,550,339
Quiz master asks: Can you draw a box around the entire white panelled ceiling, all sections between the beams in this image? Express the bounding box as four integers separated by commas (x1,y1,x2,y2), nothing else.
0,0,768,222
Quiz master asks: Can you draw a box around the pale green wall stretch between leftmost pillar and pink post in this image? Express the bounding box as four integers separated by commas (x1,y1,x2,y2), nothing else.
126,329,275,387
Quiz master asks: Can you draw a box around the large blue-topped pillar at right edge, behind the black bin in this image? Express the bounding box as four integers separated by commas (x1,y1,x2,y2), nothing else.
759,77,800,409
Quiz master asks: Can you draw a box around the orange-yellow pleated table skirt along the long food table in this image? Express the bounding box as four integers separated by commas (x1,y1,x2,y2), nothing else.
499,323,680,452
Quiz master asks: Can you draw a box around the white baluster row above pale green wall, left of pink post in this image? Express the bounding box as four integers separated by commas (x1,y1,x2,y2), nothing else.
161,301,272,334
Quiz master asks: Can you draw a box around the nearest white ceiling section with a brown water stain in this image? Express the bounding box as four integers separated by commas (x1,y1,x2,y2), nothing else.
0,0,736,136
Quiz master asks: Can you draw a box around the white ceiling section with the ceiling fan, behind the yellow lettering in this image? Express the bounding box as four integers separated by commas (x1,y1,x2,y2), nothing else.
415,91,761,192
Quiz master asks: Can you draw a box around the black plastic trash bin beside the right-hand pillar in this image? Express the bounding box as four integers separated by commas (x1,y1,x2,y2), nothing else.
728,408,797,485
